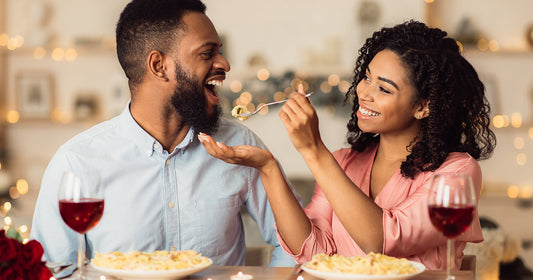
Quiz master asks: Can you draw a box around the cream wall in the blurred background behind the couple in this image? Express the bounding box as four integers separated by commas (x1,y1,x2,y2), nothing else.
3,0,533,192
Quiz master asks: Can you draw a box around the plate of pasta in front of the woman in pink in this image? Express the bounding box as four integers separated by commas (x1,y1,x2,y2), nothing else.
302,253,426,280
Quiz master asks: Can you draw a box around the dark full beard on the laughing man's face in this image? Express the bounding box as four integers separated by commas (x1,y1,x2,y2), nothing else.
171,64,220,134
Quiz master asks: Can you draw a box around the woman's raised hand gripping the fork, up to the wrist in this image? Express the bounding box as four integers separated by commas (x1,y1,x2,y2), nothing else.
279,86,324,153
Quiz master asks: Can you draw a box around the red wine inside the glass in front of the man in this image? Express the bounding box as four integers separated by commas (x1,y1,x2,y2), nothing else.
59,198,104,234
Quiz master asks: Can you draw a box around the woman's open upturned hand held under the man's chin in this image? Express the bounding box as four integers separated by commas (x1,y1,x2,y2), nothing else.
198,133,277,171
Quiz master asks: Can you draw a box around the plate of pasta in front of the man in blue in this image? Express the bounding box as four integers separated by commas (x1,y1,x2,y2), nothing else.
91,250,213,280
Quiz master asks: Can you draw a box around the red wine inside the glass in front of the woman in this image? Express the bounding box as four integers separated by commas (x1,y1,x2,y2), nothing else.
429,206,474,238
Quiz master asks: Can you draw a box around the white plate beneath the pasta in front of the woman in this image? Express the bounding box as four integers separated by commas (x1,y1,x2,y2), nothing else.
302,261,426,280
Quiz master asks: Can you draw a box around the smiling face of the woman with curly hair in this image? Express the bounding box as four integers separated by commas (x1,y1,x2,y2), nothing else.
357,49,420,137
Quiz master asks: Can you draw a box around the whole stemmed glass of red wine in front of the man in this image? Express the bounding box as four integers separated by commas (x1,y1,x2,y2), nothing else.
58,170,104,279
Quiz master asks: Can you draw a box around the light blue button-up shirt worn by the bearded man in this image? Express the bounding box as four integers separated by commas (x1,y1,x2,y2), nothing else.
31,104,295,266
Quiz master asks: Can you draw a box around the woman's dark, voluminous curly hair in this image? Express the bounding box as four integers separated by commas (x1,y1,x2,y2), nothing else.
346,21,496,178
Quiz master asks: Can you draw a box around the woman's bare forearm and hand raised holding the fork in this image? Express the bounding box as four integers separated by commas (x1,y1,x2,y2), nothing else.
279,93,383,253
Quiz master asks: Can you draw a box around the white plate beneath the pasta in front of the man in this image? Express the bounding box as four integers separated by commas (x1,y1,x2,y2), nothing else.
91,259,213,280
